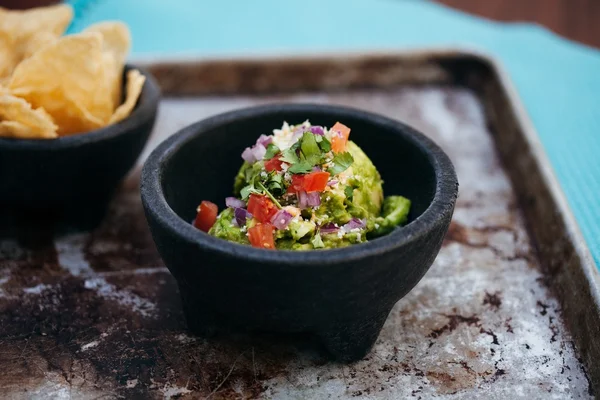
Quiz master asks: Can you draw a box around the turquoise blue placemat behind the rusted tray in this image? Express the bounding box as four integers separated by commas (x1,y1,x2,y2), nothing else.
69,0,600,266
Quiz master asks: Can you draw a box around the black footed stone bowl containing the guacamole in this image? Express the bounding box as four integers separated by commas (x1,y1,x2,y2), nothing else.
141,104,458,361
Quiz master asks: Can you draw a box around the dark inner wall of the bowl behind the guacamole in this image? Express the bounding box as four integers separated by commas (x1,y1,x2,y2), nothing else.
161,105,436,228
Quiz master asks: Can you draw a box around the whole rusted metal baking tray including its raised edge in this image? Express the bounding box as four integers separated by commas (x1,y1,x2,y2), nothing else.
0,51,600,399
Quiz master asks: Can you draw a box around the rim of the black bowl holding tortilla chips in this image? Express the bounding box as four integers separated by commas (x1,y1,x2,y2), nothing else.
0,64,161,151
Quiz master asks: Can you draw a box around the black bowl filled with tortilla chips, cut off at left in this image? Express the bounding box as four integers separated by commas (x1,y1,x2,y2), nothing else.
0,65,160,228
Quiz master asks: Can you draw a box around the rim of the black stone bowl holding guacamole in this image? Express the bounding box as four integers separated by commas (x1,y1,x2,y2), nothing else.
140,103,458,266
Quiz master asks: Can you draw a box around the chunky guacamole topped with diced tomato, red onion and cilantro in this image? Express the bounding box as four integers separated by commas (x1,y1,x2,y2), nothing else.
194,121,410,250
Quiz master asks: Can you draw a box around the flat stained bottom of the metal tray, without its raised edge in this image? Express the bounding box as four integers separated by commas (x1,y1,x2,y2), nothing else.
0,87,592,399
